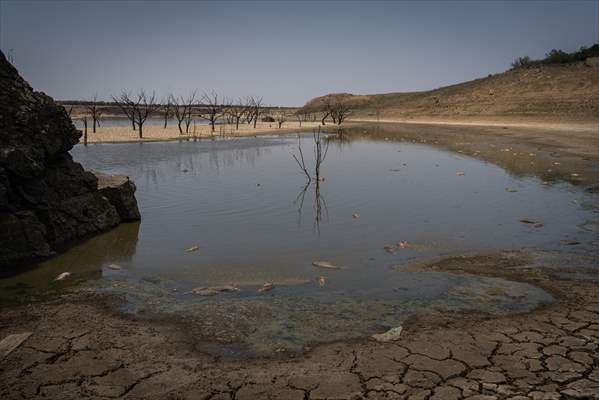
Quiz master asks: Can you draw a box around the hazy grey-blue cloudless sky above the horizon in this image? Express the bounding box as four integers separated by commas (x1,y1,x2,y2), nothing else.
0,0,599,106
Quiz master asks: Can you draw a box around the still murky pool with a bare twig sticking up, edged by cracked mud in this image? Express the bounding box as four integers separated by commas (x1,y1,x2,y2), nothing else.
0,135,597,355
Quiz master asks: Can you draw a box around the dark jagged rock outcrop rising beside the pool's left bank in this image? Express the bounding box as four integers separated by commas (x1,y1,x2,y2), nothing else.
0,52,139,272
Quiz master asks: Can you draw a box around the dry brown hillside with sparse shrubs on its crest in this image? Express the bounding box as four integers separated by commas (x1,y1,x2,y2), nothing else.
304,58,599,121
